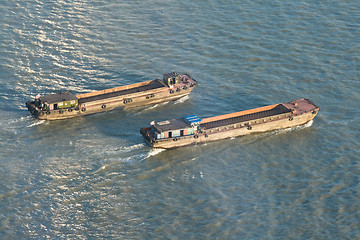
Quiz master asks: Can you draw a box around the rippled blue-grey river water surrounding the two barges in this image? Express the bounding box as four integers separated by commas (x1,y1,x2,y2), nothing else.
0,0,360,239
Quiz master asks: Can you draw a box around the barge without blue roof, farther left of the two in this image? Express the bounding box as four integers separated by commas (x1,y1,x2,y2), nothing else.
26,72,197,120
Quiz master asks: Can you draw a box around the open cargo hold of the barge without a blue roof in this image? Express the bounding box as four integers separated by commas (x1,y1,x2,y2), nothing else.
79,79,166,104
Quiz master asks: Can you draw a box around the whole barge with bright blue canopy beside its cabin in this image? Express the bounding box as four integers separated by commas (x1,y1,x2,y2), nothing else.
140,99,320,149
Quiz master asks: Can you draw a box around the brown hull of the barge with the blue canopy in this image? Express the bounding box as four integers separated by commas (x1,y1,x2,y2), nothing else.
141,98,319,149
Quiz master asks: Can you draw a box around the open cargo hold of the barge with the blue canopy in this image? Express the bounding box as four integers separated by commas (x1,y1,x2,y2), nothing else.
200,104,291,129
